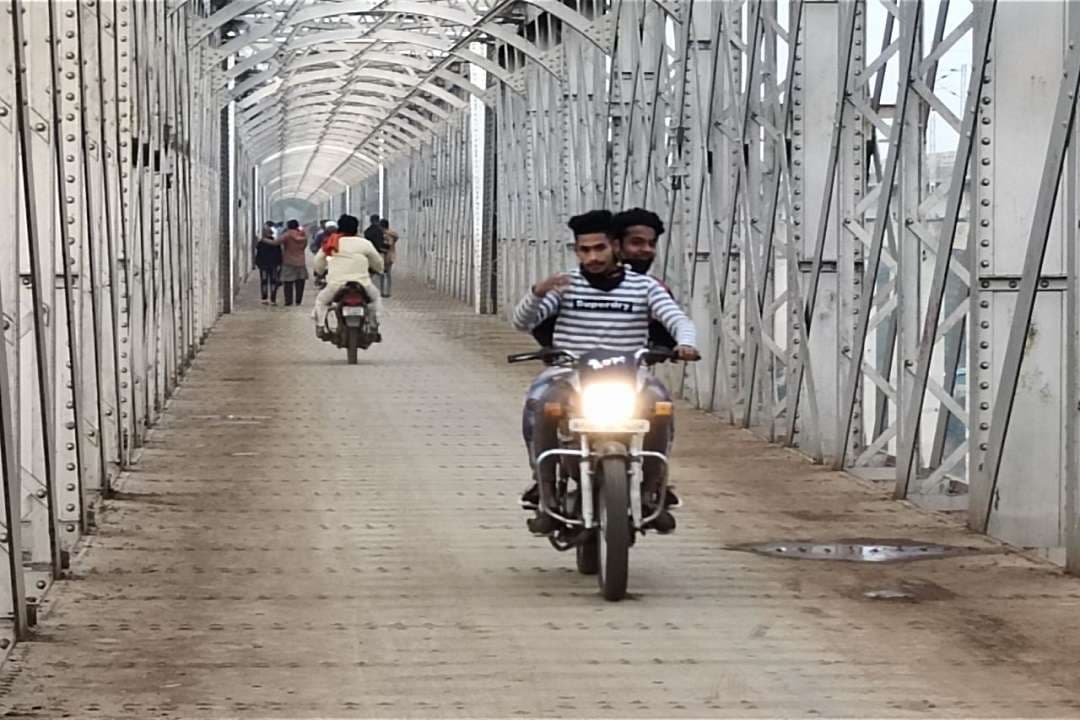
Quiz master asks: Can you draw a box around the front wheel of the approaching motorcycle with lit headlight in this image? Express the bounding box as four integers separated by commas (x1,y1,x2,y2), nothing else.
586,457,631,601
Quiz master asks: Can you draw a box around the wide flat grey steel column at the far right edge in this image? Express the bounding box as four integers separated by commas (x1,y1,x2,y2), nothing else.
969,3,1080,547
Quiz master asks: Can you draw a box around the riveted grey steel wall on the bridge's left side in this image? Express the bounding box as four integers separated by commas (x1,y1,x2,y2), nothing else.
0,0,240,651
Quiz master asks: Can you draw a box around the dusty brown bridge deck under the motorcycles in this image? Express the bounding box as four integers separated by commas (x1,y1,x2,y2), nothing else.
0,282,1080,718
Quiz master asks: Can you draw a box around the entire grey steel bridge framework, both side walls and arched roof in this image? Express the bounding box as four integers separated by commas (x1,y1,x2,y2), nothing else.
0,0,1080,660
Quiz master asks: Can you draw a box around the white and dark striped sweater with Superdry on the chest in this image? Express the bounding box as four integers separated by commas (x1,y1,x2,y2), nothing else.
513,270,697,352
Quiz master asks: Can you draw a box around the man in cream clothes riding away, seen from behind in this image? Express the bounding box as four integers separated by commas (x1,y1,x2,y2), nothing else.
312,215,382,342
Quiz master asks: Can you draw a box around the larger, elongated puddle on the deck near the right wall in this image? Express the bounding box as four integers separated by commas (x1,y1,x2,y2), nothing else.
731,540,987,562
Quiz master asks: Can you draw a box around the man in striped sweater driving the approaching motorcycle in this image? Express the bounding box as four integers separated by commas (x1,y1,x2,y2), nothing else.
513,210,700,534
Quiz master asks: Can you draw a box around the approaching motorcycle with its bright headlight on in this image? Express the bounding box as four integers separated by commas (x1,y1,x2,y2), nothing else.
507,348,676,601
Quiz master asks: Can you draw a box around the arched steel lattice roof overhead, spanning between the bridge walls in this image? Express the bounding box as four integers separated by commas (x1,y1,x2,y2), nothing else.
194,0,609,199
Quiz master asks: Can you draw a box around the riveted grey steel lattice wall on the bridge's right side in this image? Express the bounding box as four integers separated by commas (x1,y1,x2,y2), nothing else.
382,0,1080,571
